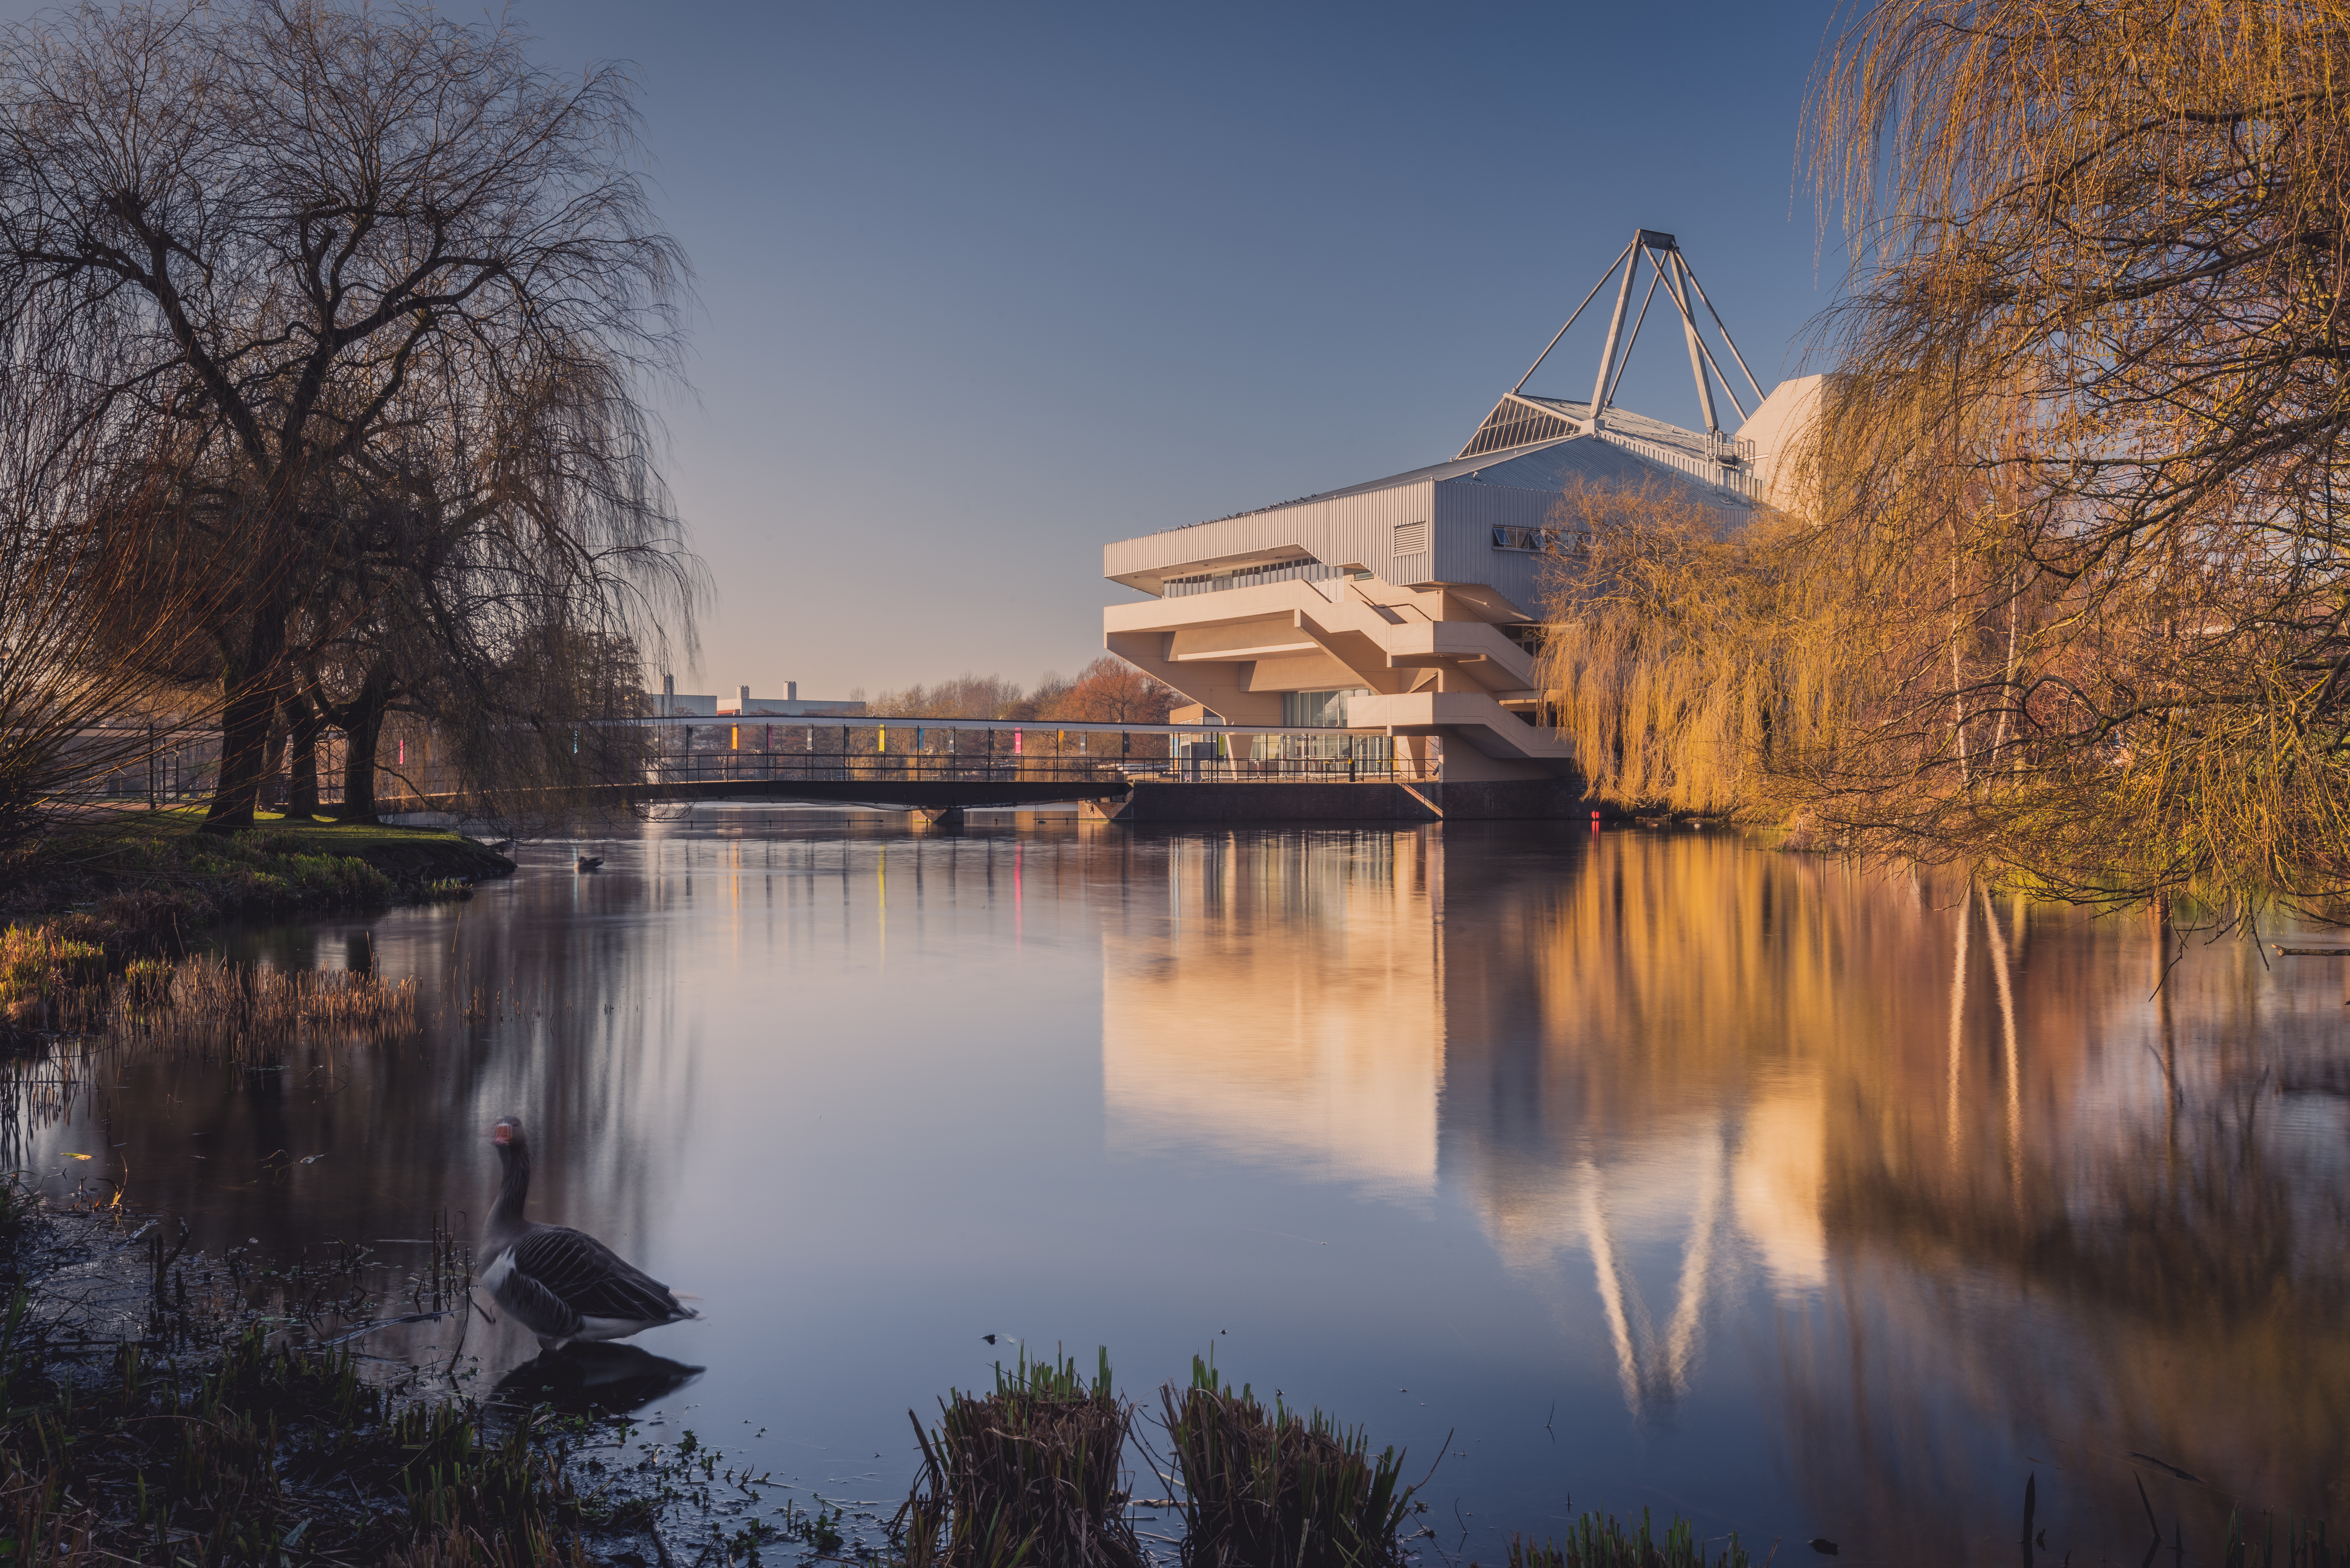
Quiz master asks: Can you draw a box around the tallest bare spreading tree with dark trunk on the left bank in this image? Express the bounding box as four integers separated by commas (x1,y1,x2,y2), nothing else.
0,0,684,827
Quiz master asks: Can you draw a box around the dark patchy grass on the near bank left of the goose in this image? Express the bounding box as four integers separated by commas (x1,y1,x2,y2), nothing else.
0,1215,656,1568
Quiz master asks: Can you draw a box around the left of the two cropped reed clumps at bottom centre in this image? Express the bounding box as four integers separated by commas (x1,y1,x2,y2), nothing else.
891,1349,1144,1568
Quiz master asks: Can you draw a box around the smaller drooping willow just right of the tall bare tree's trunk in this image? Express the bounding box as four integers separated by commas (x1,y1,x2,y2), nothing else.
289,334,707,820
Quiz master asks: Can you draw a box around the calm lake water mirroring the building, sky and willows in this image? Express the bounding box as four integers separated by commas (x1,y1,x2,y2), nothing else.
18,827,2350,1563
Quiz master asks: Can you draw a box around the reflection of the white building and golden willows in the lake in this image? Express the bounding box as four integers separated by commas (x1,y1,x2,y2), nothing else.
1102,827,2350,1542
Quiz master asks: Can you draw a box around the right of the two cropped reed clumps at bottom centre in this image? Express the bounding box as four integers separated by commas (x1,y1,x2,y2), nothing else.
1158,1356,1419,1568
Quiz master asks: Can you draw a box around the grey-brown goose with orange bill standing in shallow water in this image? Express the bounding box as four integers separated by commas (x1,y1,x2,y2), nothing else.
482,1117,700,1349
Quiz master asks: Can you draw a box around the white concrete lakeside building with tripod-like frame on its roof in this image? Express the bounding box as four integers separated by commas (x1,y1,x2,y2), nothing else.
1102,230,1816,799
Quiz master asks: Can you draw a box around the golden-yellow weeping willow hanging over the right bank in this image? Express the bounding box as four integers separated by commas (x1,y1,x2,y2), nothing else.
1560,0,2350,901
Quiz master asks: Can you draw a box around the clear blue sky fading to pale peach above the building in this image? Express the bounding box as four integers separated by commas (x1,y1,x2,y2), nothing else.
517,0,1840,696
